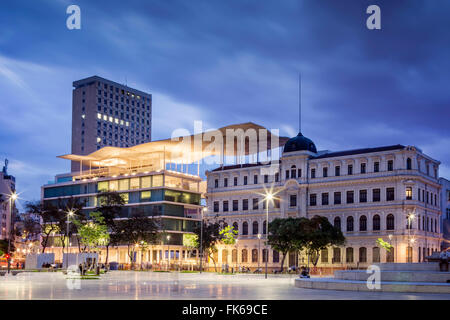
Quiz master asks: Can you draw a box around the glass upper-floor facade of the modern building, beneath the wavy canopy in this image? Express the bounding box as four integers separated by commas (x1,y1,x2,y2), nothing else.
43,174,201,244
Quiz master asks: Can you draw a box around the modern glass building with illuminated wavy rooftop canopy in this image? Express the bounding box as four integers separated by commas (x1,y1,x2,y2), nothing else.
42,140,203,264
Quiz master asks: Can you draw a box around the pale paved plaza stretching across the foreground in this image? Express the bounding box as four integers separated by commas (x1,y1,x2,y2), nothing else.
0,271,450,300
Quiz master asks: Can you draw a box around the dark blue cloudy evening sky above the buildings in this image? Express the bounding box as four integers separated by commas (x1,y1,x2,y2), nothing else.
0,0,450,201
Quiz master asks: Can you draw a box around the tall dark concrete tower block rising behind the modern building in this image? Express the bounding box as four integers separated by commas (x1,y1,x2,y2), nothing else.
72,76,152,171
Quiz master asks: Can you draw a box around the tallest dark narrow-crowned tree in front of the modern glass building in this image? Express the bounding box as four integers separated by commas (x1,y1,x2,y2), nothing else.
97,192,125,263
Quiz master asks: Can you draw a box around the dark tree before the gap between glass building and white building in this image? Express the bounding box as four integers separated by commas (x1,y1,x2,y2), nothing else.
194,216,223,272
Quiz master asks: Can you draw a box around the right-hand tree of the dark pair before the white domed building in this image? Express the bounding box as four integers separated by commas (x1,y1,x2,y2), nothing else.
300,216,345,266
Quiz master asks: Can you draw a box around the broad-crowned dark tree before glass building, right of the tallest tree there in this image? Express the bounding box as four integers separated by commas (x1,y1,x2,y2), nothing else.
111,212,159,268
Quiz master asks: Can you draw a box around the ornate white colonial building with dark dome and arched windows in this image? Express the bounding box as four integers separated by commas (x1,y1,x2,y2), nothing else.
206,133,442,269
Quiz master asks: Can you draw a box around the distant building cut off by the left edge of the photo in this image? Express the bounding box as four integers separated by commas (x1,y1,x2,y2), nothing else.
0,160,16,240
